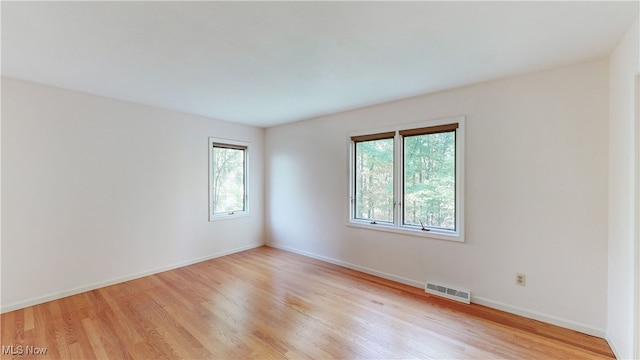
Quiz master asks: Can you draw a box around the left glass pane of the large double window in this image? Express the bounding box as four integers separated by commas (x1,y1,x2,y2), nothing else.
354,139,393,222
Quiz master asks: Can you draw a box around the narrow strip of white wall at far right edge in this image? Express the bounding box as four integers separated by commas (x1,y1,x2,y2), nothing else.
607,20,640,359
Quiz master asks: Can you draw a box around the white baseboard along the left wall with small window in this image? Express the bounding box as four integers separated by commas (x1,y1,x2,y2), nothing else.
0,243,264,314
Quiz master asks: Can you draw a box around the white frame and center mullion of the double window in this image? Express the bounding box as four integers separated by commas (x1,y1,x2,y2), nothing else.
347,116,465,242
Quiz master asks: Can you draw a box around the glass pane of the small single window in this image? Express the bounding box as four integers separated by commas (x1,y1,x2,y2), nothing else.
213,147,245,214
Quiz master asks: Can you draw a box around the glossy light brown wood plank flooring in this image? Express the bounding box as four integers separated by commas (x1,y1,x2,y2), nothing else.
0,247,613,359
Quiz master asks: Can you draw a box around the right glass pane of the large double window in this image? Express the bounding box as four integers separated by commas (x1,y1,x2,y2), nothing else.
403,131,456,230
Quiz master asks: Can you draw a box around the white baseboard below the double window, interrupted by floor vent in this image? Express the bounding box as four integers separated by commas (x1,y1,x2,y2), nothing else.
265,243,615,340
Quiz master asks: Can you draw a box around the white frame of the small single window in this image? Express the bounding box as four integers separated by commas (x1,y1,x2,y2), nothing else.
209,137,251,221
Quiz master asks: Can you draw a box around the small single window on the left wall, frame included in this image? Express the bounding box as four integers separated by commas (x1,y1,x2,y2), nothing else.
209,138,249,220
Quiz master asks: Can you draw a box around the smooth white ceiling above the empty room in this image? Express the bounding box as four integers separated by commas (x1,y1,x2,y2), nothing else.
1,1,638,127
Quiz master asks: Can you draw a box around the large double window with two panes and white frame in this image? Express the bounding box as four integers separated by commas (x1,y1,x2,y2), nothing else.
349,117,464,241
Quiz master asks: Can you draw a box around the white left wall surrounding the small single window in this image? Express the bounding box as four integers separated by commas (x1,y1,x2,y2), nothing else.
1,78,264,311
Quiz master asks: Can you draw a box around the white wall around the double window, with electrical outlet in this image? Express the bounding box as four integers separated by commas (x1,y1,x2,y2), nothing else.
265,61,608,336
